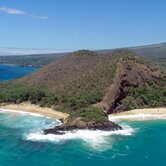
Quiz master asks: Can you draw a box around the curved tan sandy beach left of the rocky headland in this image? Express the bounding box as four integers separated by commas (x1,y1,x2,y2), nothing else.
0,103,68,121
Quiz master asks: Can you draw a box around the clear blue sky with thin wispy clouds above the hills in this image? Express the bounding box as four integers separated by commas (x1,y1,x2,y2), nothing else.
0,0,166,51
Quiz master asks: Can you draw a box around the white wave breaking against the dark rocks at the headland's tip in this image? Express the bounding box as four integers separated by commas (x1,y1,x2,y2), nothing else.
24,126,134,149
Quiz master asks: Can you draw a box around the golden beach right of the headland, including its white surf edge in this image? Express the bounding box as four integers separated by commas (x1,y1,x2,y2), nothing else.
109,108,166,121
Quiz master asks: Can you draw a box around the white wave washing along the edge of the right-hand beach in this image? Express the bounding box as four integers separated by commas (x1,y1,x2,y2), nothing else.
109,114,166,122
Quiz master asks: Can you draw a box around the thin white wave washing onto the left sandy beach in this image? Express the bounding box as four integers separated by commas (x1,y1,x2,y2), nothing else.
0,108,44,117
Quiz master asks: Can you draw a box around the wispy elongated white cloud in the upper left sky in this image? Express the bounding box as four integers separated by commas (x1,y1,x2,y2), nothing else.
0,6,48,20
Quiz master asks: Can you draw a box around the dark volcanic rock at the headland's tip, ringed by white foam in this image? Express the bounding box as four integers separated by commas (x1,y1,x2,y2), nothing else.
44,118,123,135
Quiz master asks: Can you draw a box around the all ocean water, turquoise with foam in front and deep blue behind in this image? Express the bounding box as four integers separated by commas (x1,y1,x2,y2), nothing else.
0,65,166,166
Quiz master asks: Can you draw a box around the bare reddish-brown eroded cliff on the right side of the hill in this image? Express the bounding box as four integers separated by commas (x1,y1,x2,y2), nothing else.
95,59,162,114
